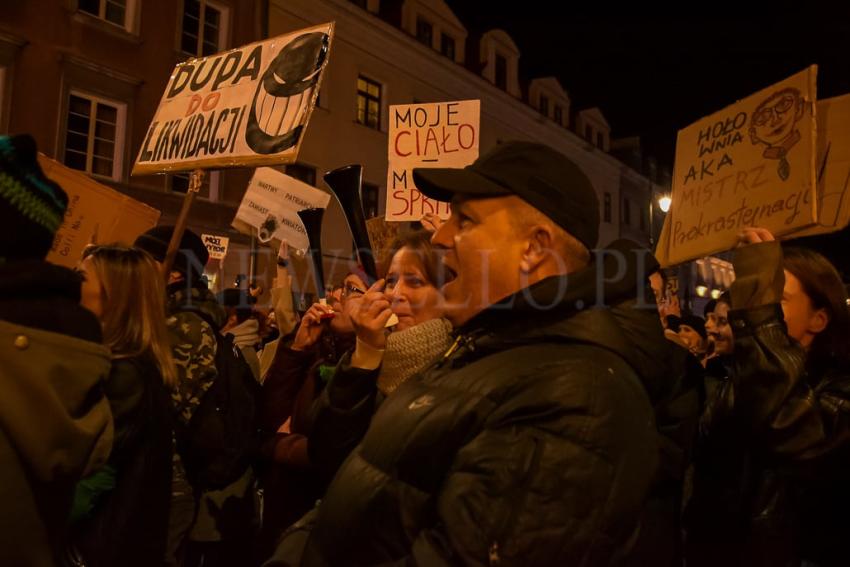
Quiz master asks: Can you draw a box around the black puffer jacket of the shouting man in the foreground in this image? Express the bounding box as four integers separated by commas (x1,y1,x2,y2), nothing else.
290,242,669,566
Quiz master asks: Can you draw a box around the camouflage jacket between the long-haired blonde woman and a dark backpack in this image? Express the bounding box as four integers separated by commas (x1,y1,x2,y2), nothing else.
168,282,226,423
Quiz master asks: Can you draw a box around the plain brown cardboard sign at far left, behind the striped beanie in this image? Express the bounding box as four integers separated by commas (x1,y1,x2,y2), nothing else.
38,154,160,268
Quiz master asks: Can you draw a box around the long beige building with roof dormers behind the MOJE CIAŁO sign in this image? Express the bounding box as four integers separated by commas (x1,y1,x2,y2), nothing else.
269,0,669,262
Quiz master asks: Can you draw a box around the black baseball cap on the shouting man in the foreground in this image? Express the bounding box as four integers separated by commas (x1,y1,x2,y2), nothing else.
413,141,599,249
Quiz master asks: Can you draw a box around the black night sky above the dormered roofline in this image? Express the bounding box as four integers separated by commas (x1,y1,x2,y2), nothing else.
448,0,850,171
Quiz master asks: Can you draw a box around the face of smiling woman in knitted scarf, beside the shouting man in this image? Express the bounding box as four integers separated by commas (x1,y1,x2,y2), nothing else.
385,246,443,331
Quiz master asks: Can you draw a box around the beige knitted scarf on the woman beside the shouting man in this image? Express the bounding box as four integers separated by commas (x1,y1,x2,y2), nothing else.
378,319,452,395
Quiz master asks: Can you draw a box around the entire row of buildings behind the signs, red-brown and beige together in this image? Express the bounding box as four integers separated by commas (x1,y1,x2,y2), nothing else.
0,0,668,302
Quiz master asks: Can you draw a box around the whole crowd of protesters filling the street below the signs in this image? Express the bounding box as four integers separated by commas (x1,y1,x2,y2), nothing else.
0,136,850,567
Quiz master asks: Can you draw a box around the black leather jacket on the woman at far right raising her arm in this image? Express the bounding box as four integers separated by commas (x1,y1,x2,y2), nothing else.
686,242,850,566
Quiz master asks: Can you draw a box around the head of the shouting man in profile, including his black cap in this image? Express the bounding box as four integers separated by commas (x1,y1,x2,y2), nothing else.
413,142,599,327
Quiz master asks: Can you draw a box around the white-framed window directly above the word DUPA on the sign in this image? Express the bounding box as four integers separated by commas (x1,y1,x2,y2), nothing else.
180,0,230,57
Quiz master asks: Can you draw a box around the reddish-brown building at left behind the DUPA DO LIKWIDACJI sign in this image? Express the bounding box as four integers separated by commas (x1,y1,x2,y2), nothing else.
0,0,267,287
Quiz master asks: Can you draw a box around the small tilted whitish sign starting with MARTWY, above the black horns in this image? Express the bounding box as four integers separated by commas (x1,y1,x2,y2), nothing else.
233,167,331,250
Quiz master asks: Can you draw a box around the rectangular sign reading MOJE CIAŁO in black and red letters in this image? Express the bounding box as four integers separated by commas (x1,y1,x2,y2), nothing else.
386,100,481,221
